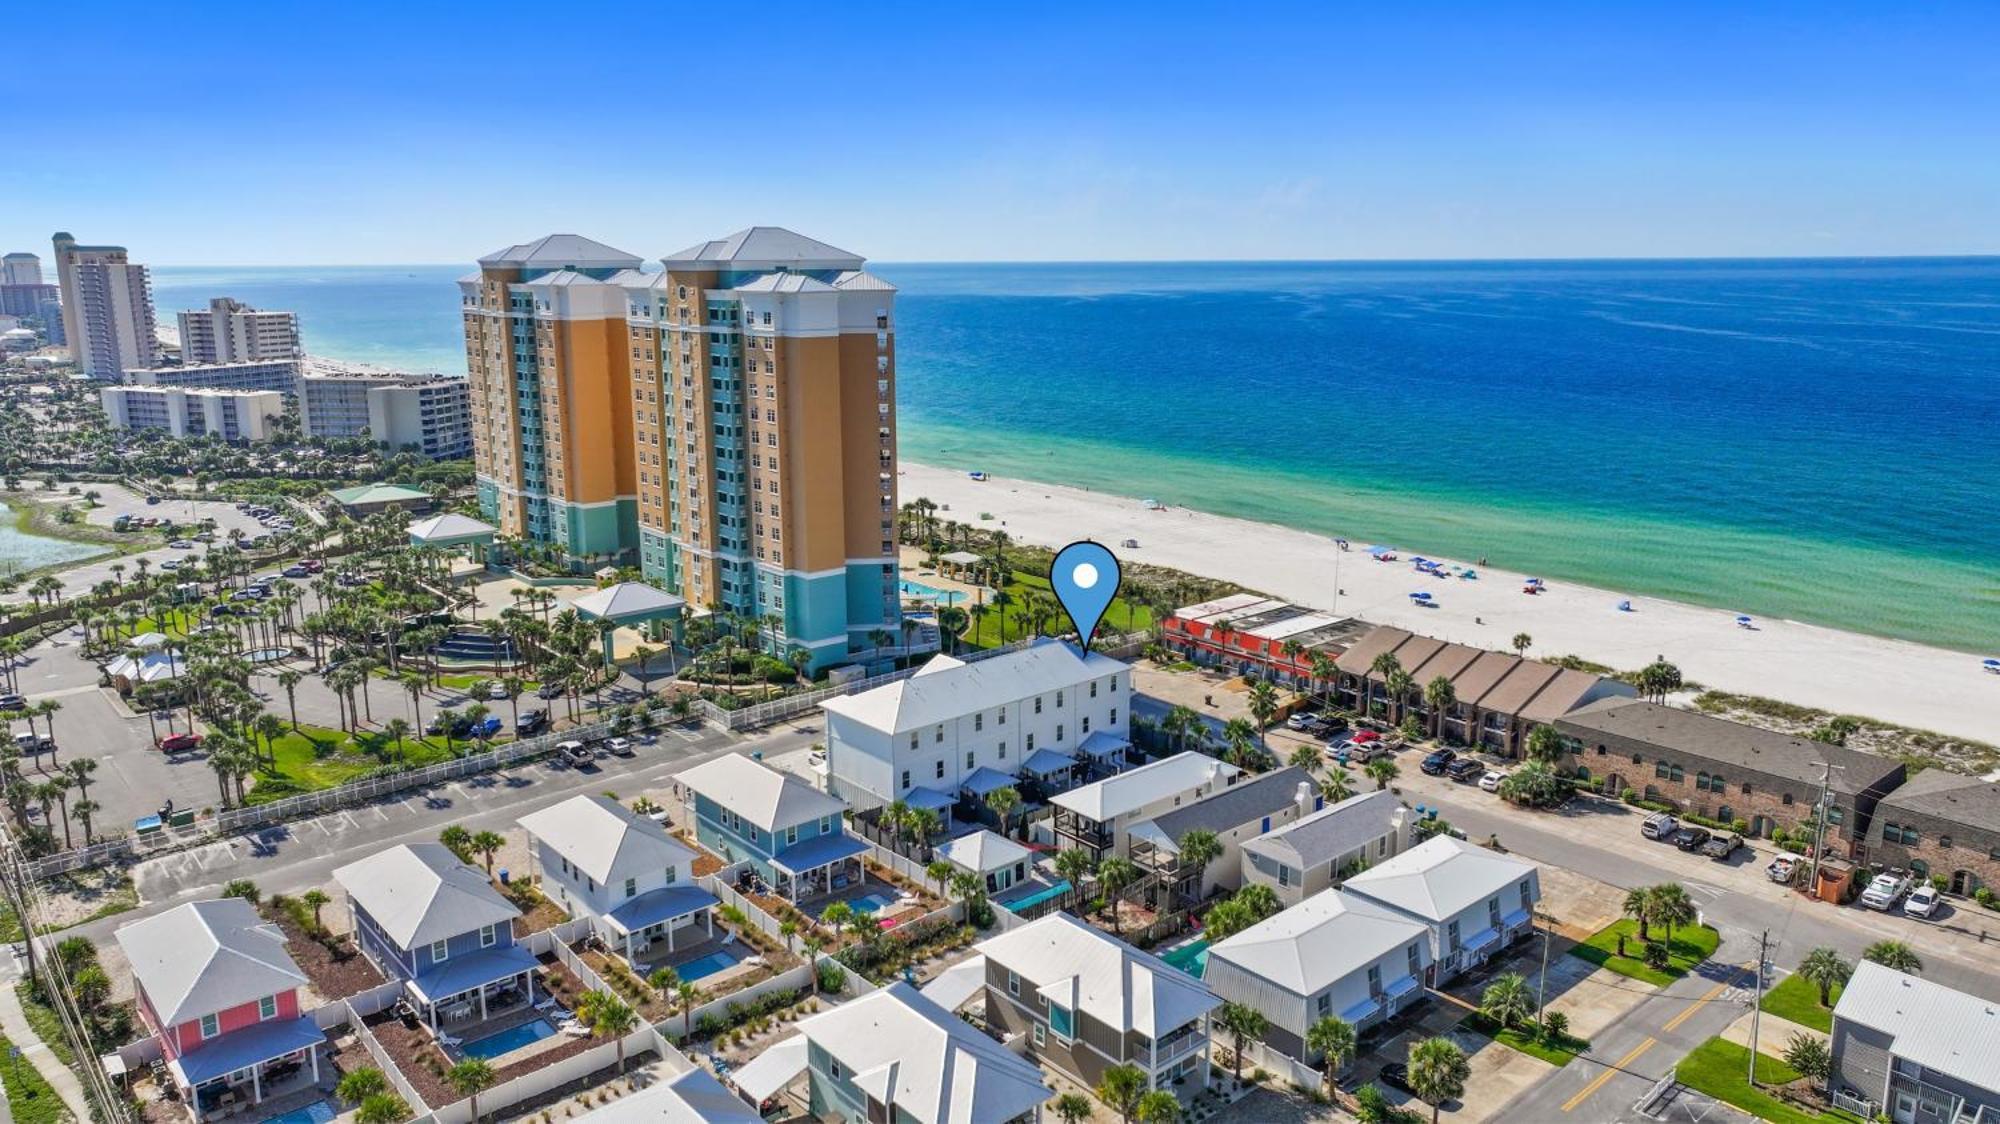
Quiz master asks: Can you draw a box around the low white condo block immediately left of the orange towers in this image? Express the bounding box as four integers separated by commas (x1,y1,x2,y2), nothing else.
298,368,472,460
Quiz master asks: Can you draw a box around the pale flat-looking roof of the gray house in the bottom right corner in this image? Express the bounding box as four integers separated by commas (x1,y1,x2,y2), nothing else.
1834,960,2000,1094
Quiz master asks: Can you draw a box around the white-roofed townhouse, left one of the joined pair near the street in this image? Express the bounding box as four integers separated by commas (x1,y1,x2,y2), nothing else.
1202,890,1430,1066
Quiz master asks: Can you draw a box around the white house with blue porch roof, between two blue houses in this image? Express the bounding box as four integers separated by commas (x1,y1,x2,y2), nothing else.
520,796,718,966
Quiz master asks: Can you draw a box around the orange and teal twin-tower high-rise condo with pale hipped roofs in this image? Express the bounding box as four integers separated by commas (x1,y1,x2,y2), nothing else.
460,226,908,668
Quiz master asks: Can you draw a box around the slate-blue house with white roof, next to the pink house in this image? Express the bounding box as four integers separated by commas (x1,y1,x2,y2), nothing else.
334,842,536,1028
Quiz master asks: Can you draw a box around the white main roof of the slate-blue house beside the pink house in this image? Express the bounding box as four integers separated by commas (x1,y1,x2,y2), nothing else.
334,842,520,948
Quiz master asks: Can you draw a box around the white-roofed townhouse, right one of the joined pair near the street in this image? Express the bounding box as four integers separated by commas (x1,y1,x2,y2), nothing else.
1340,836,1542,986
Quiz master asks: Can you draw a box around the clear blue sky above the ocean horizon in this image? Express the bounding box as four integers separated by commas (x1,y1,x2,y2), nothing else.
0,0,2000,264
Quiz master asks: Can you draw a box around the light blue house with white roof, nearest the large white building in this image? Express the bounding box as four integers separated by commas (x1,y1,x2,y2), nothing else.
674,754,868,902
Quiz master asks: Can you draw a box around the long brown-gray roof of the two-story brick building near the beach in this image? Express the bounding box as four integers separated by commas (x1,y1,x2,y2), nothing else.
1556,698,1902,796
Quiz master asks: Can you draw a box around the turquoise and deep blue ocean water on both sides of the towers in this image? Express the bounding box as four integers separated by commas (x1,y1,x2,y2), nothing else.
156,258,2000,652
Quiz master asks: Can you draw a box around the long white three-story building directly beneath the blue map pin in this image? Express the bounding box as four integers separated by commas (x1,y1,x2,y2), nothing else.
820,640,1132,812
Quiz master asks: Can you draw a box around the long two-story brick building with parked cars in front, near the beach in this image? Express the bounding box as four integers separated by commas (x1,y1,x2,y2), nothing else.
1556,698,1904,848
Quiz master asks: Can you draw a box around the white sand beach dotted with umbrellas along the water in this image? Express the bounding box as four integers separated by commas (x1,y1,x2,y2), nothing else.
900,462,2000,742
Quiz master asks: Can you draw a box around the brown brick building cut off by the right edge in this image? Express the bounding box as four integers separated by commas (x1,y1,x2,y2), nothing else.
1868,768,2000,894
